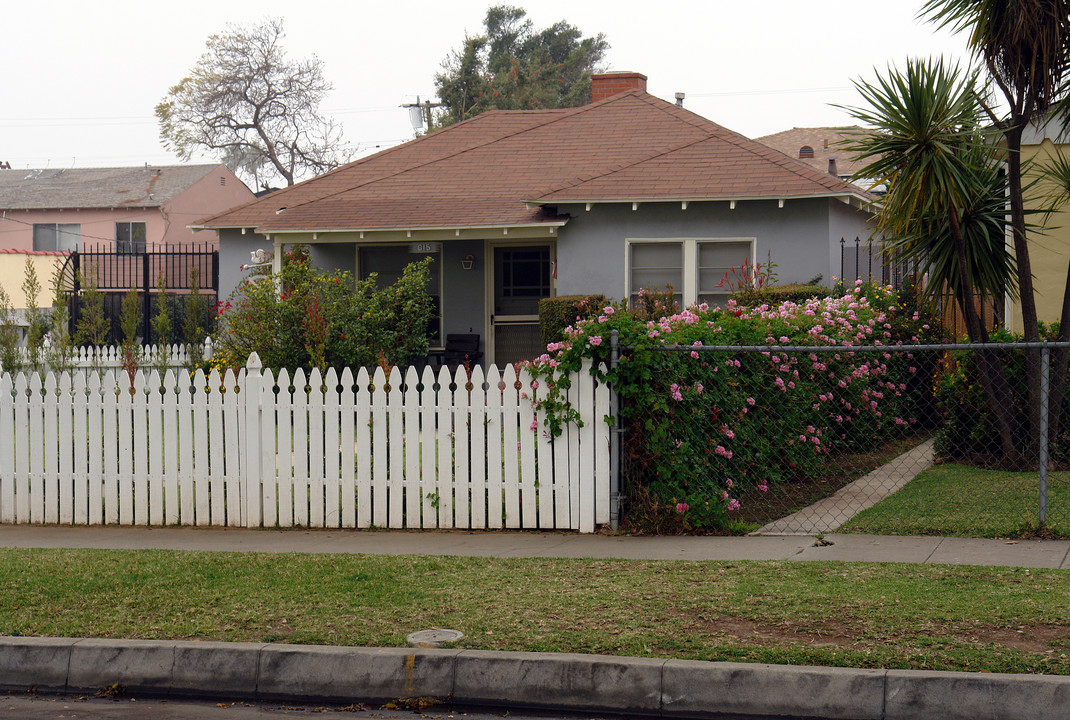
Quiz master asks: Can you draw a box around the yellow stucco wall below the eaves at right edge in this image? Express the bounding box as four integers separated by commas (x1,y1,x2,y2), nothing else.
1007,139,1070,333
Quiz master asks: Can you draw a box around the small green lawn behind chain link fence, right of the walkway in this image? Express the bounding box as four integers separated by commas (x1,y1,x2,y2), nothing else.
840,463,1070,537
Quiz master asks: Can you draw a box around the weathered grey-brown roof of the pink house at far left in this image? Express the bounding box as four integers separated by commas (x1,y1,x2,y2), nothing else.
0,164,219,210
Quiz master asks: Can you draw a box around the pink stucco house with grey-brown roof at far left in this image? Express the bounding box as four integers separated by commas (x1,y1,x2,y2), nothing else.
0,165,254,254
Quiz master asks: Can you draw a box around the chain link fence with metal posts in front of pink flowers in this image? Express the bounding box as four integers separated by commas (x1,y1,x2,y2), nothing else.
618,343,1070,537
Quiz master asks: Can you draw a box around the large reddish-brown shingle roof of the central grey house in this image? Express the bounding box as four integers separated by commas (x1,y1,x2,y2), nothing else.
199,90,862,232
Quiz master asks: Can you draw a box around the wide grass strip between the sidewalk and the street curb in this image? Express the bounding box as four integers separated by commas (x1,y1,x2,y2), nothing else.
0,549,1070,674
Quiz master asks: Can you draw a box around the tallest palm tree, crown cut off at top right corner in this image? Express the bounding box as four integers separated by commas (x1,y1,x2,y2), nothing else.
919,0,1070,455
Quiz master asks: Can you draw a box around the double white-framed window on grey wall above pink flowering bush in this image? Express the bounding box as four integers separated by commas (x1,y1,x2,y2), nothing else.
628,238,754,307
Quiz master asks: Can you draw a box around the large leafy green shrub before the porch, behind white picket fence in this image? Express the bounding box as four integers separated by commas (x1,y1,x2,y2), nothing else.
213,247,433,368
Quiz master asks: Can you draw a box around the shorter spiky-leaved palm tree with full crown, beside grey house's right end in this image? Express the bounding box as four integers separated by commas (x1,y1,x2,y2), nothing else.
845,60,1019,464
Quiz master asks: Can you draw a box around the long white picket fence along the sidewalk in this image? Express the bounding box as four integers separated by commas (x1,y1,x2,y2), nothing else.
0,355,610,532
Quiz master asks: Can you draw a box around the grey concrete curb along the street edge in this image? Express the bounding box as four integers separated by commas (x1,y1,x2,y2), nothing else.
0,637,1070,720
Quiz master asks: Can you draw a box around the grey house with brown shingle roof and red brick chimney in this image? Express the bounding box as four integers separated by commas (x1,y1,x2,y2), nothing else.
195,73,874,364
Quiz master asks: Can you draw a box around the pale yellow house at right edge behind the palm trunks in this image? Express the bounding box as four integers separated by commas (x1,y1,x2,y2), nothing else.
1005,121,1070,333
